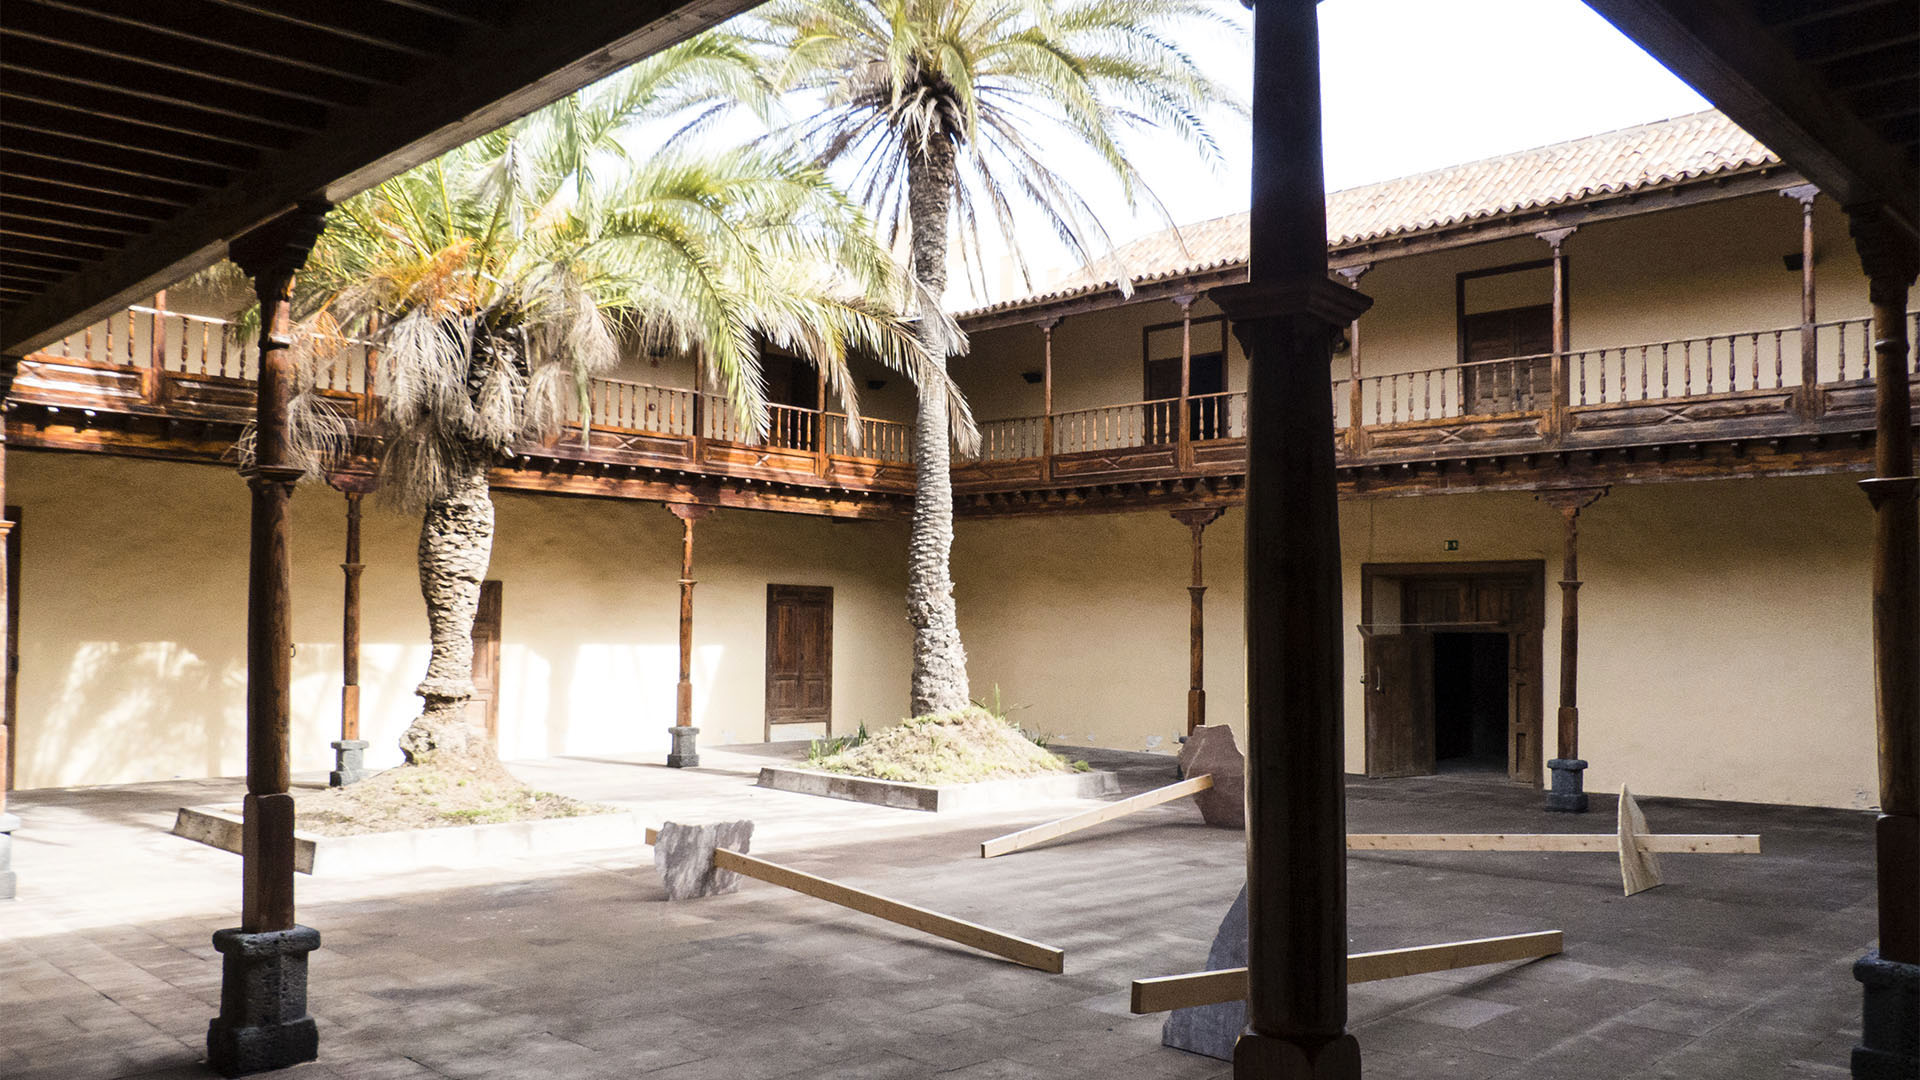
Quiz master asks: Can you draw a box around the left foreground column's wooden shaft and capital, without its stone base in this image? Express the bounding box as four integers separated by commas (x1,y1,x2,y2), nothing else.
228,206,326,934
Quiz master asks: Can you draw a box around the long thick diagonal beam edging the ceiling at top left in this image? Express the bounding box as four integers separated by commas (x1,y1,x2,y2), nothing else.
0,0,753,356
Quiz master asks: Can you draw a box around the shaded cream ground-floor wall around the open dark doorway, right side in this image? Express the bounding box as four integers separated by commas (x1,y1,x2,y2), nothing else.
954,477,1878,807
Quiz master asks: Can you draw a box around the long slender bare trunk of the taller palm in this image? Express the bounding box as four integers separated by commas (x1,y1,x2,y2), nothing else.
906,136,968,717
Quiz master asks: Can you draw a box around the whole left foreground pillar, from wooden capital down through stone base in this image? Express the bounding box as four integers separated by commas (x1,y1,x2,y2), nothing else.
207,206,326,1076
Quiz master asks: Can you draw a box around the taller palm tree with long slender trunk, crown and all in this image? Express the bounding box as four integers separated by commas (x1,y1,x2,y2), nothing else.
741,0,1233,715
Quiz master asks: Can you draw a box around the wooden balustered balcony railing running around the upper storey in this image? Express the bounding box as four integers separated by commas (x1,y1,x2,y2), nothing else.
13,304,1920,494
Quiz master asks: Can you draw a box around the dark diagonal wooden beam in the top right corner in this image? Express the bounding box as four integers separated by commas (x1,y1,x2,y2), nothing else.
1586,0,1920,236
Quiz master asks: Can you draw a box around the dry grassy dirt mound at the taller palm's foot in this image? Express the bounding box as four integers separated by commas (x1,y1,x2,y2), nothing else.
810,709,1075,784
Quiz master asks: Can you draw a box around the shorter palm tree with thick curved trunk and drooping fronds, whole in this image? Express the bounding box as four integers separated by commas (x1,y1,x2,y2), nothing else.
284,37,922,769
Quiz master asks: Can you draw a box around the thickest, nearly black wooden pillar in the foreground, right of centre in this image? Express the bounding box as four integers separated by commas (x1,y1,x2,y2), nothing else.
1212,0,1369,1080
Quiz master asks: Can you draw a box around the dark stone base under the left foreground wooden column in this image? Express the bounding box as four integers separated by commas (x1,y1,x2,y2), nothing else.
207,926,321,1076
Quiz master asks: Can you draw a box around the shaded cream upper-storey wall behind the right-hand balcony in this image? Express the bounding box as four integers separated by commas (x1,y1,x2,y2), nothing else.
954,194,1868,419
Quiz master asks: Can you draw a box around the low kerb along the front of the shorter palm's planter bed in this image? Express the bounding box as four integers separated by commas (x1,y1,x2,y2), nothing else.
173,805,647,876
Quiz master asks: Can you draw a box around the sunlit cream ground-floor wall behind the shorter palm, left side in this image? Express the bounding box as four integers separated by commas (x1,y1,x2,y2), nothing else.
8,452,910,788
